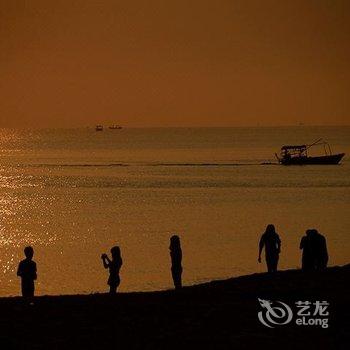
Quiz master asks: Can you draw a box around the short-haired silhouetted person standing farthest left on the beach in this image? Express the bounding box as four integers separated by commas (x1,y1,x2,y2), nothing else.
17,247,37,298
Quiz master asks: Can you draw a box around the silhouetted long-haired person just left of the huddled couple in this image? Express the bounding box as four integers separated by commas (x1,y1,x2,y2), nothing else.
258,224,281,272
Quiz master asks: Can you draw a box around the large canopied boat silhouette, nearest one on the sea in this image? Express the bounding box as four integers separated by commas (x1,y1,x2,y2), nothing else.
275,139,345,165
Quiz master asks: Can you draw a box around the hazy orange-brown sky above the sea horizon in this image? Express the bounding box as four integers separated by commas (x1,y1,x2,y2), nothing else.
0,0,350,127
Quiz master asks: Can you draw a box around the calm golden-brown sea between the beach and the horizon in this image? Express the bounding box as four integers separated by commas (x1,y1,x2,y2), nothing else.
0,127,350,296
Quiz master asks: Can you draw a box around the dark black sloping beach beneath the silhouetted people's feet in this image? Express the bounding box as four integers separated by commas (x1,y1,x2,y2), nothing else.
0,265,350,350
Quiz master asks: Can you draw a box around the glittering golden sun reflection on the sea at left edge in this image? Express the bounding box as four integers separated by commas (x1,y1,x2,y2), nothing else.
0,137,57,295
